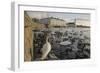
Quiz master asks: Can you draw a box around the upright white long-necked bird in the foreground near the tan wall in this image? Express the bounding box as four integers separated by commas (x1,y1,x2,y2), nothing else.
40,36,51,60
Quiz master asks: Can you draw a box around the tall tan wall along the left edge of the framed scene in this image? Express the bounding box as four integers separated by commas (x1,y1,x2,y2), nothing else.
24,12,32,61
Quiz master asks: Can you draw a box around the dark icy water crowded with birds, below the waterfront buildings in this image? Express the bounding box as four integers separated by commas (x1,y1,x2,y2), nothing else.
34,27,90,60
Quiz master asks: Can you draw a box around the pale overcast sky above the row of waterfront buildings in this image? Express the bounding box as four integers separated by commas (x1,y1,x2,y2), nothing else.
27,11,90,22
